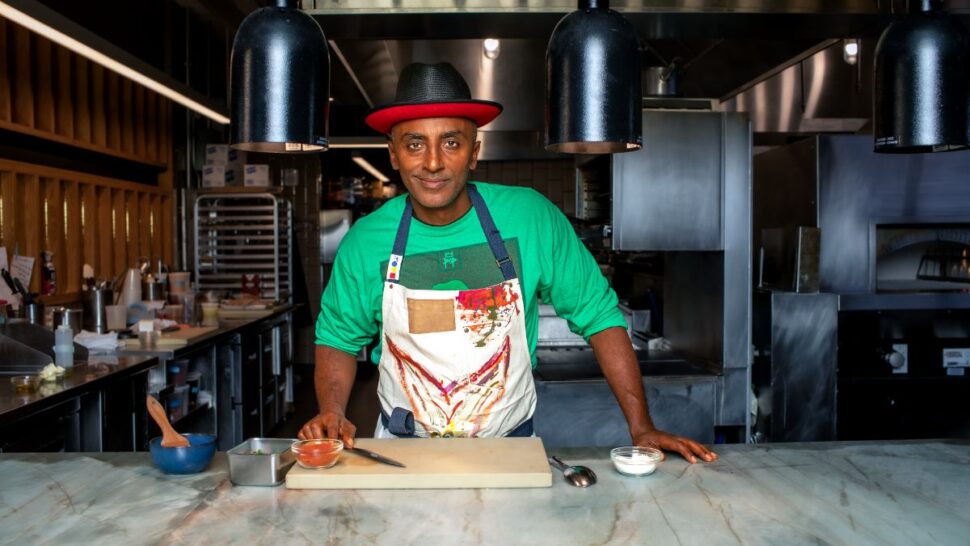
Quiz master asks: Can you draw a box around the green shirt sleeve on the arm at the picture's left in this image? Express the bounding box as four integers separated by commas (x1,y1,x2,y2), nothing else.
316,224,383,355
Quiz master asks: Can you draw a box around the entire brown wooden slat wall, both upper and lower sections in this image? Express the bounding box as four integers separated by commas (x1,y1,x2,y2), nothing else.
0,18,174,303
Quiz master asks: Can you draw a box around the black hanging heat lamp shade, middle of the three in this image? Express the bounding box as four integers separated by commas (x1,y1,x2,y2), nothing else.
545,0,643,154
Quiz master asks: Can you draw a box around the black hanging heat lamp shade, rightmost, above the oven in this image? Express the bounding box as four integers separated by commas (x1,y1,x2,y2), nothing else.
873,0,970,153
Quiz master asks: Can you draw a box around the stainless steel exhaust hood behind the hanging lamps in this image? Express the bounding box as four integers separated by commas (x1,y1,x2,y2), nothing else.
290,0,970,155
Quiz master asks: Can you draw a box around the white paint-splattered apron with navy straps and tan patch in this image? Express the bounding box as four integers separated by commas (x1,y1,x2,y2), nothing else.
377,184,536,437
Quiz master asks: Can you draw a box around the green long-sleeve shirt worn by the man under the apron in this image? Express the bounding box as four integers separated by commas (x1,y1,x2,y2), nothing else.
316,182,626,365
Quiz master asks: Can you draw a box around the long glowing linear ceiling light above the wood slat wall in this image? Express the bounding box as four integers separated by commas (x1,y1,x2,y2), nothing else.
0,2,229,124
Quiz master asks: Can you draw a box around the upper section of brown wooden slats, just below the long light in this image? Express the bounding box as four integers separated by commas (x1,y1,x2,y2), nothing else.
0,19,171,168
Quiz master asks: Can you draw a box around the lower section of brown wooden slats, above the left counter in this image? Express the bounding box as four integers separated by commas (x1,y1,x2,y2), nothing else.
0,159,173,295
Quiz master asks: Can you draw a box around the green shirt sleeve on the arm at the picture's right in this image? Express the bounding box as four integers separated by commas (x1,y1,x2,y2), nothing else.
538,192,627,341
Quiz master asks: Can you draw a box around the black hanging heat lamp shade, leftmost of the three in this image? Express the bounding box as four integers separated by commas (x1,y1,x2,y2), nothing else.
229,0,330,152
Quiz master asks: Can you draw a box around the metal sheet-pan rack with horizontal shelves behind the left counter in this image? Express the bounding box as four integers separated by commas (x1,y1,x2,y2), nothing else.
195,193,293,302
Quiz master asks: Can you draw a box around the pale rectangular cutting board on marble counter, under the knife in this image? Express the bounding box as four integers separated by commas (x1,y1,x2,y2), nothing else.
286,438,552,489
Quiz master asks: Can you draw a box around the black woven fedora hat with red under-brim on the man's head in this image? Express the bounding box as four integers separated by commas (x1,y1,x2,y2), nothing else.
364,63,502,134
